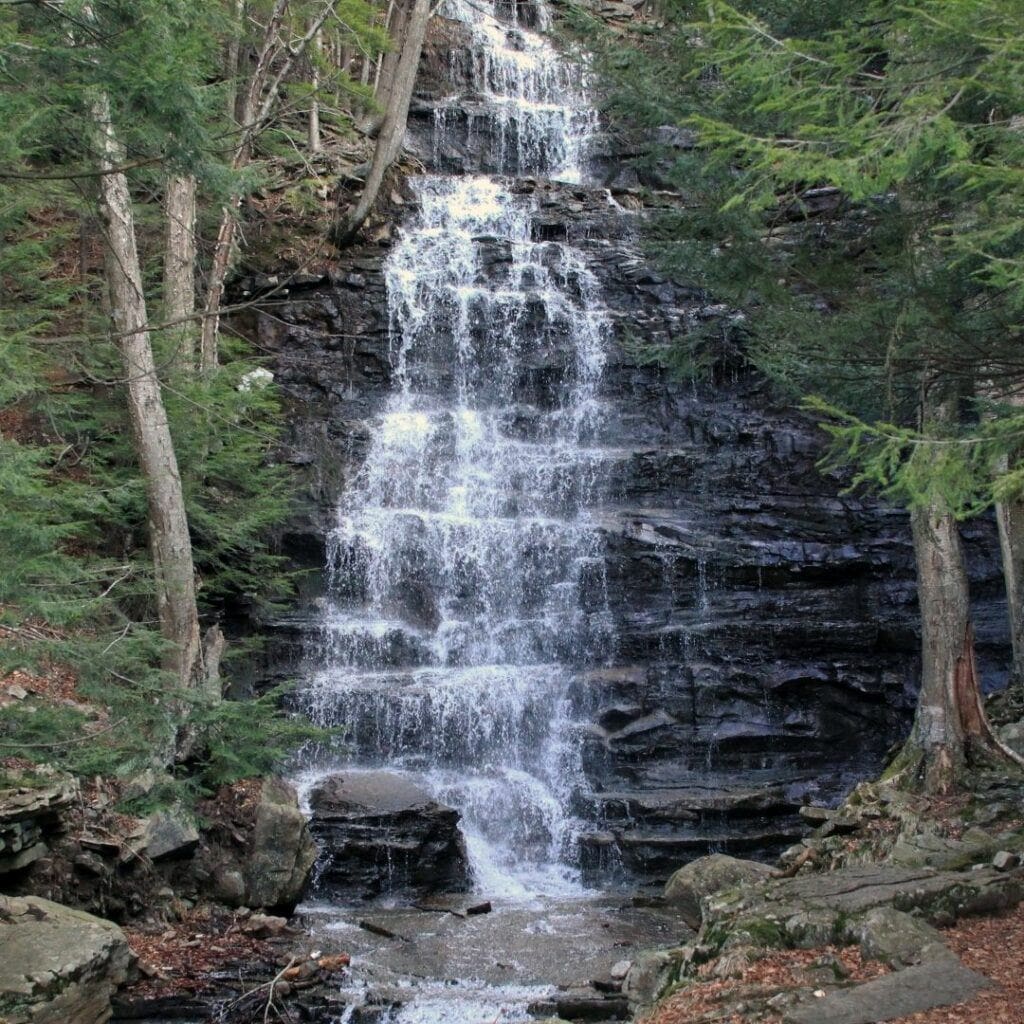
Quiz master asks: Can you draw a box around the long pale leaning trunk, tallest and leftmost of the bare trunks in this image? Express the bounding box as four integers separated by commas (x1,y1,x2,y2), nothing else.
93,97,203,720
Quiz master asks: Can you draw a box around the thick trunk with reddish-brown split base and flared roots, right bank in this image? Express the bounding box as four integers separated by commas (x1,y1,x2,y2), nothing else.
891,507,1021,794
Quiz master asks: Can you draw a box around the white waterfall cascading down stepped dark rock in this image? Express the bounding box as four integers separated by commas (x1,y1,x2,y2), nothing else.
304,0,613,896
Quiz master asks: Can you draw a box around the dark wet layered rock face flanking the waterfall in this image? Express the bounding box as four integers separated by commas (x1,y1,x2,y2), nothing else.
230,16,1006,885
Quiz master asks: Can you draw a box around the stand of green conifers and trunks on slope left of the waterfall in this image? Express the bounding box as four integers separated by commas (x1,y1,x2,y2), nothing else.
0,0,390,784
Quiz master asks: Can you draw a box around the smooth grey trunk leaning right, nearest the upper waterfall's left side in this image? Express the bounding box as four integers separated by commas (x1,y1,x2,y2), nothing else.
331,0,430,247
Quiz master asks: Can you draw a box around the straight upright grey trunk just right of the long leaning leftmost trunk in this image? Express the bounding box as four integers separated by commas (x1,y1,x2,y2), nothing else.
164,174,196,372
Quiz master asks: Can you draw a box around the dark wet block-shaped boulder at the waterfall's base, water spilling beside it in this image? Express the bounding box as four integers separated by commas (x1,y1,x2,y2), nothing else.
310,771,470,898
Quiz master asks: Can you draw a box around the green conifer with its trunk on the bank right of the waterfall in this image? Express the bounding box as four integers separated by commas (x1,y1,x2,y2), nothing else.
577,0,1024,791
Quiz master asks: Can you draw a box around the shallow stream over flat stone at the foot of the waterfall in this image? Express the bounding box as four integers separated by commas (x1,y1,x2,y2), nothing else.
300,896,692,1024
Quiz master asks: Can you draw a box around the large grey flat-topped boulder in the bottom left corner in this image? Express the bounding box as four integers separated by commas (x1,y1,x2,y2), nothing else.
0,896,132,1024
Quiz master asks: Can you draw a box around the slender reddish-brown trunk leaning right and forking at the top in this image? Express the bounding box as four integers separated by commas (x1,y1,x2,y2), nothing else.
200,0,335,372
